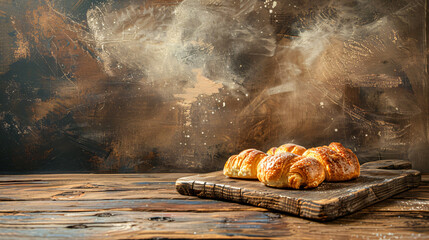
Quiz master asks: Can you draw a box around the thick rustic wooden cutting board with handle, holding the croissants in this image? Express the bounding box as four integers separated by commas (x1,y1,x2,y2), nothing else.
176,160,421,221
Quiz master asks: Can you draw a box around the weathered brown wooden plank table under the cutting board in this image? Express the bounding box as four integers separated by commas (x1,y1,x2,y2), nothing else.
0,173,429,239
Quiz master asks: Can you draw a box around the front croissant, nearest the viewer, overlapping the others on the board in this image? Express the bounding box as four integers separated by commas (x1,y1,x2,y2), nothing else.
257,152,325,189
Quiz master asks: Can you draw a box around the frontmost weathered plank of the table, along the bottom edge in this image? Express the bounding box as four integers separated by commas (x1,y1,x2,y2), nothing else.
0,211,429,239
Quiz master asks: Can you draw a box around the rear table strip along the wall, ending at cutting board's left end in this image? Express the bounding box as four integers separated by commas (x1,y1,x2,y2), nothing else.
0,173,195,201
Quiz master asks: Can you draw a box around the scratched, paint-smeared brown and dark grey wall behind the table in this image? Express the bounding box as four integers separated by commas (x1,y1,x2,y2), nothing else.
0,0,429,172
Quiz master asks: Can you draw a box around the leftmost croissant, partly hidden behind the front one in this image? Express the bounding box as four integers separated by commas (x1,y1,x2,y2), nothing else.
223,149,267,179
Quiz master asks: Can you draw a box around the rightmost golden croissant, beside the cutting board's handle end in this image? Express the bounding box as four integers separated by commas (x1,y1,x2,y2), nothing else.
303,142,360,182
